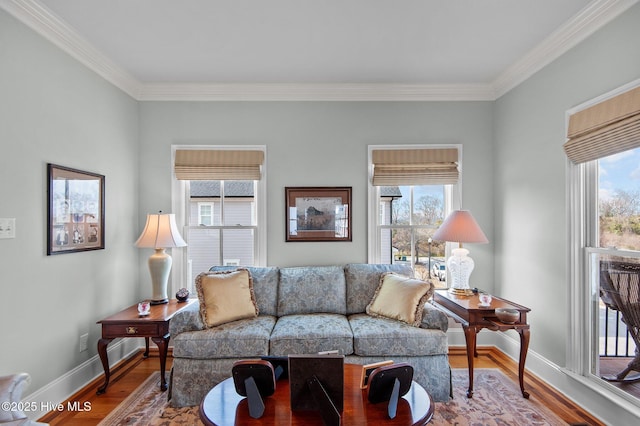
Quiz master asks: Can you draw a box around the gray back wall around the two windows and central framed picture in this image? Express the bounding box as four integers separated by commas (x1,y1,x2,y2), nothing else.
140,102,493,270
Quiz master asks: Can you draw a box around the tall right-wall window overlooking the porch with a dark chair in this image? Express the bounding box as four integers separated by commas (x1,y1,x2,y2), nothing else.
565,82,640,406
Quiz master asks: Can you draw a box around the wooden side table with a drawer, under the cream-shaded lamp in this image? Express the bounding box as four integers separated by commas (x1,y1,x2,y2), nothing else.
96,299,195,395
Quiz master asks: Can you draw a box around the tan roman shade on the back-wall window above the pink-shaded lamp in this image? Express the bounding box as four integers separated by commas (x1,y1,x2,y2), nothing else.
371,148,458,186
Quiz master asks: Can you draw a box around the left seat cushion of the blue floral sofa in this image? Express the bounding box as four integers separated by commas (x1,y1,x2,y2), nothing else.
171,315,276,358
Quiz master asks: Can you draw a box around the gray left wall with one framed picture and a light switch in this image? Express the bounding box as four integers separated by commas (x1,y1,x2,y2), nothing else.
0,11,139,393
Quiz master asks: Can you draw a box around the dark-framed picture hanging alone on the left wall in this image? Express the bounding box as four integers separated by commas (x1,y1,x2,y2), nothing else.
47,163,105,256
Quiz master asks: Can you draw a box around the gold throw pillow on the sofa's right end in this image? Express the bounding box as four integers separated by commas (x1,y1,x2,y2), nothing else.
366,272,433,327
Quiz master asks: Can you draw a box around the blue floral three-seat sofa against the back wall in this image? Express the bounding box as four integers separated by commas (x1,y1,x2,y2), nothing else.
168,264,452,407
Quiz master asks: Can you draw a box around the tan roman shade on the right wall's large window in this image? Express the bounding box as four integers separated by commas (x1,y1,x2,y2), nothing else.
564,87,640,164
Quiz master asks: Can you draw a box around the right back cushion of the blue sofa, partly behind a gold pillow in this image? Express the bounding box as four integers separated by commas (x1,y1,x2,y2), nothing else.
344,263,413,315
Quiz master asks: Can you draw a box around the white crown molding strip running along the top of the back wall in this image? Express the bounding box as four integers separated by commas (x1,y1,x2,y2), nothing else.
139,83,495,101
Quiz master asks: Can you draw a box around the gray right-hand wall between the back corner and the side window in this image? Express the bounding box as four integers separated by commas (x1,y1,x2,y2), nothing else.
494,1,640,366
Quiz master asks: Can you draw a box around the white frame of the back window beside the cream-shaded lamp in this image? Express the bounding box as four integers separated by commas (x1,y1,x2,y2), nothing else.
169,145,268,294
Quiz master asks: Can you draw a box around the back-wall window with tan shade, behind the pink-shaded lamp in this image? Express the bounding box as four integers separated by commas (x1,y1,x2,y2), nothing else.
369,145,460,286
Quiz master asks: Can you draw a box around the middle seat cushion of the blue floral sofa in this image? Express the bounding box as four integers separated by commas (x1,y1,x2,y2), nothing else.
269,314,353,356
